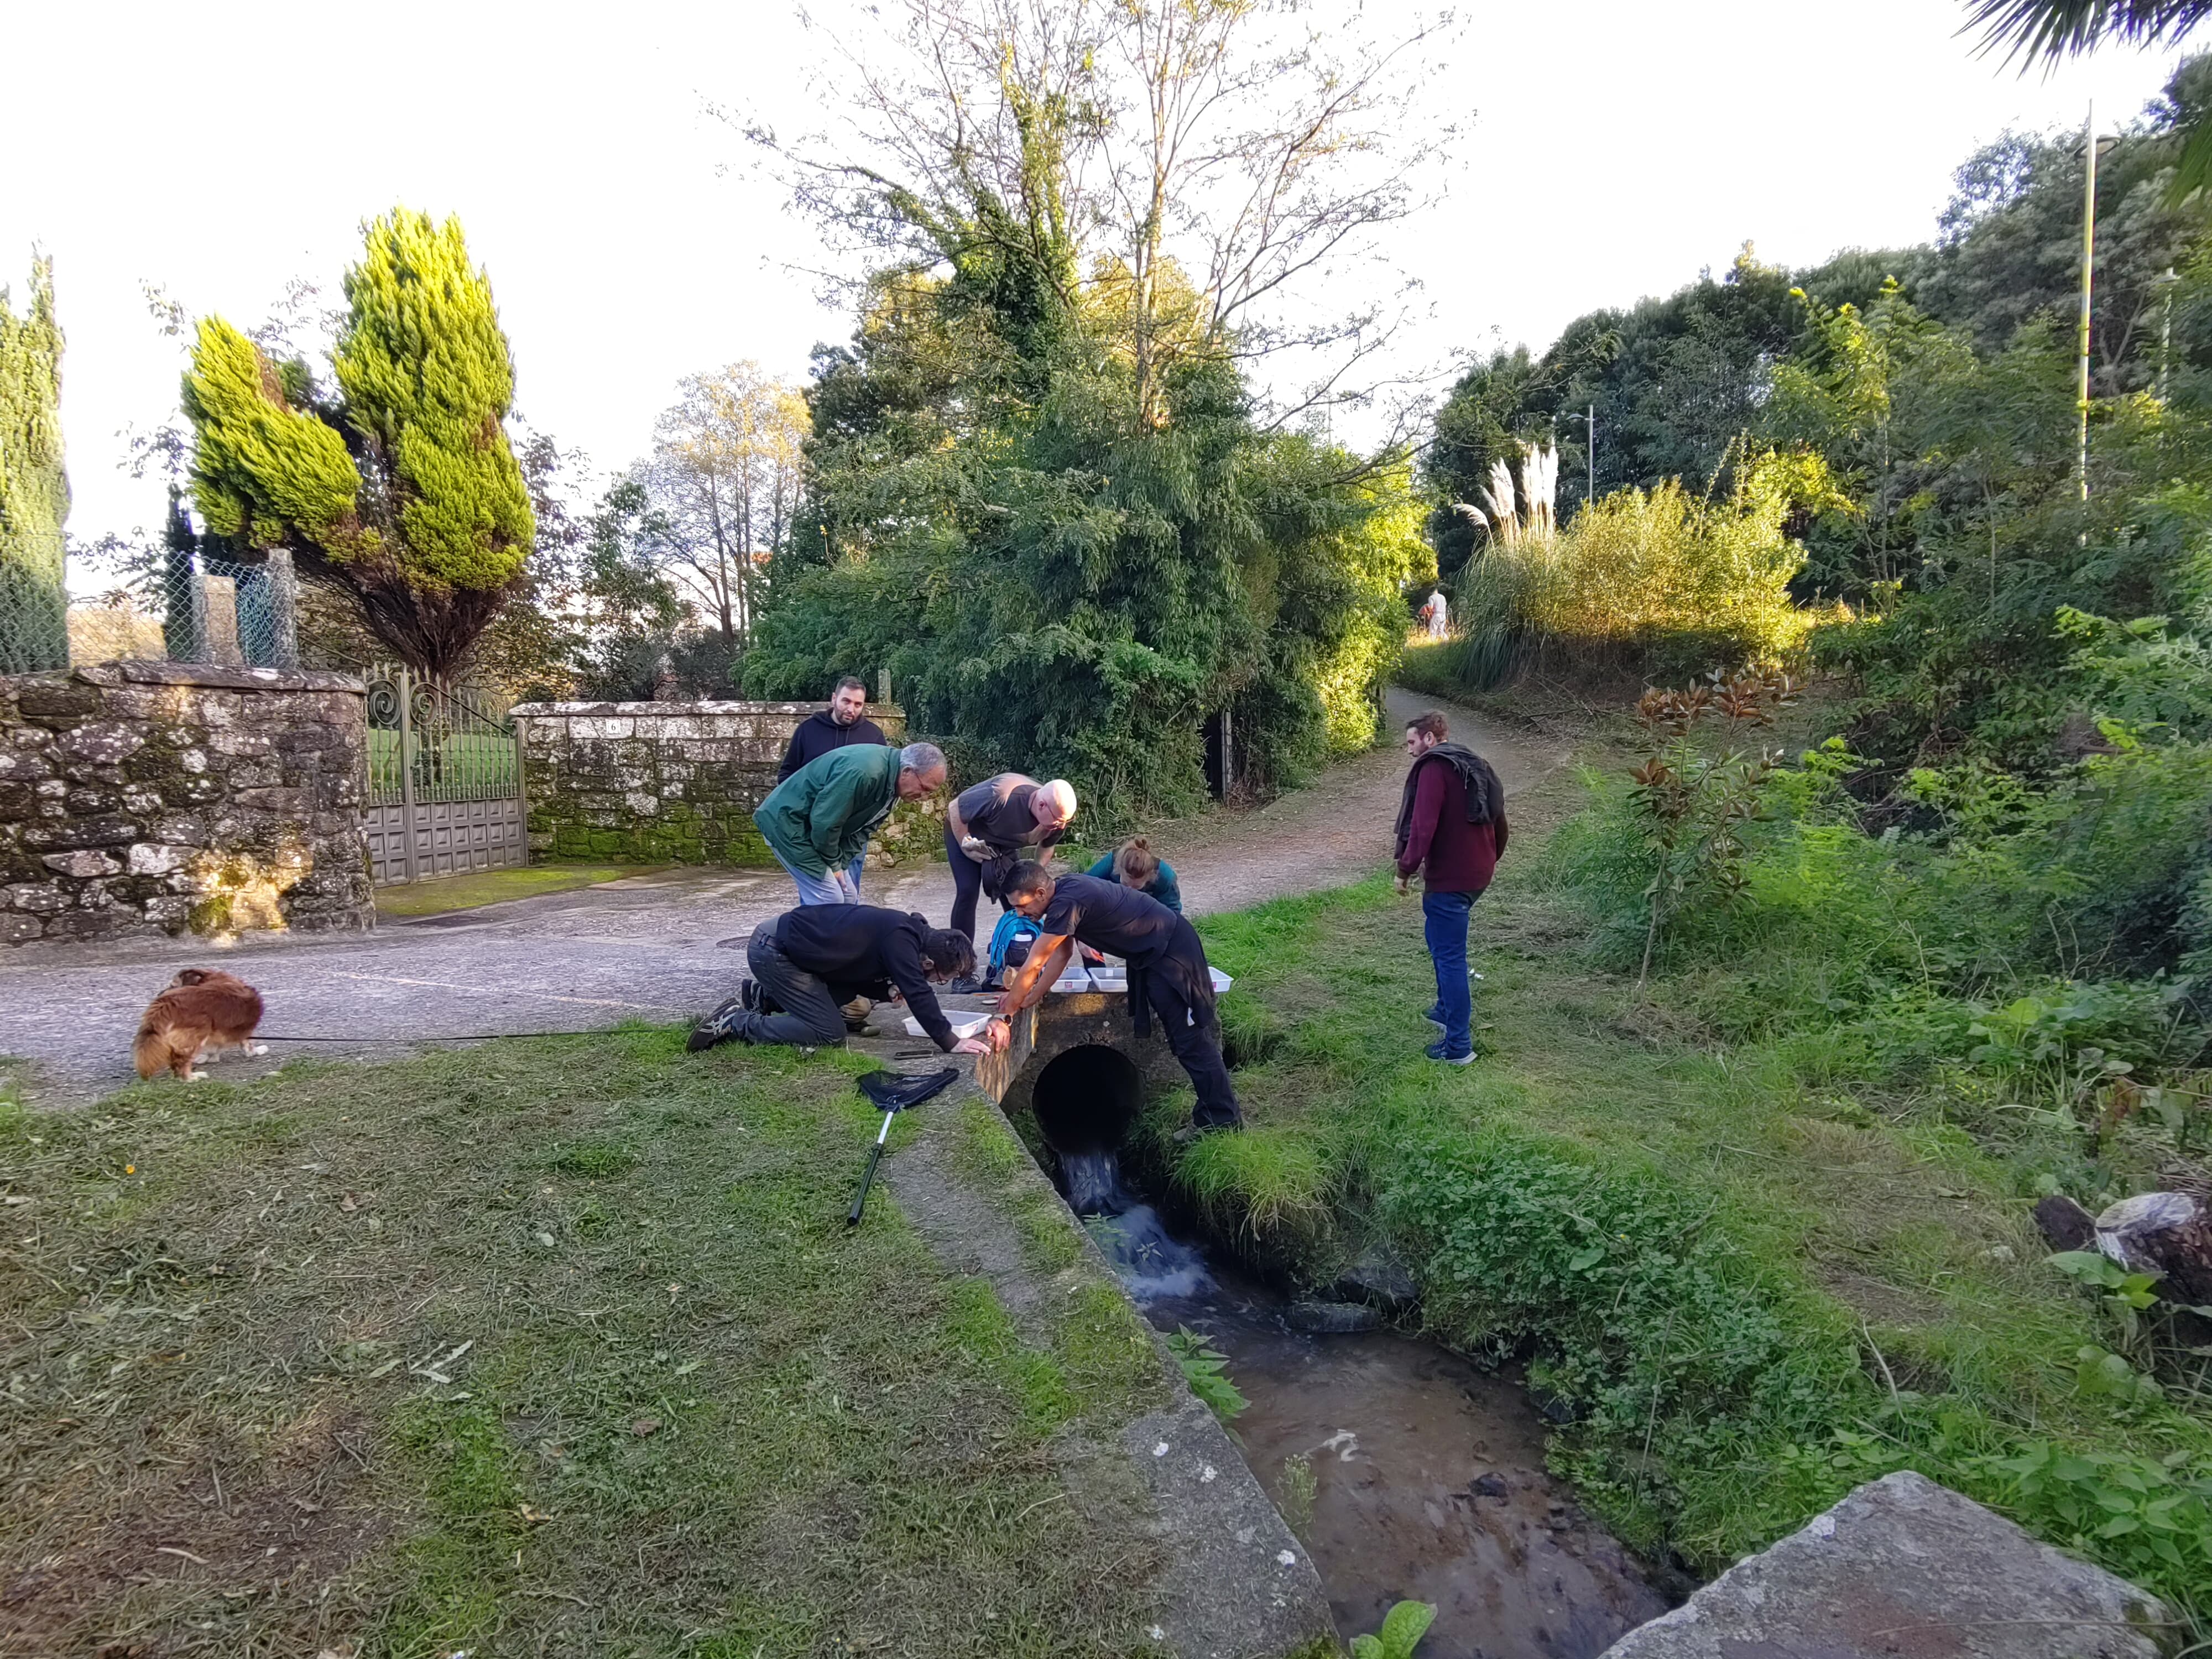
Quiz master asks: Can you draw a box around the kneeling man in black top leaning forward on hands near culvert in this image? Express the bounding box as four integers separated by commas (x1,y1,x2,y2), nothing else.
686,905,989,1055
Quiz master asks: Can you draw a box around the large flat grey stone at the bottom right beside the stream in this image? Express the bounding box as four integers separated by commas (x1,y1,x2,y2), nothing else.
1604,1473,2177,1659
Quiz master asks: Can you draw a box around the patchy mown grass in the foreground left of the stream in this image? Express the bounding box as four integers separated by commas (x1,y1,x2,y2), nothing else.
0,1029,1164,1659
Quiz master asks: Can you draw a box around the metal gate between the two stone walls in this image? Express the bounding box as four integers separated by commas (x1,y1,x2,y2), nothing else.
367,664,531,885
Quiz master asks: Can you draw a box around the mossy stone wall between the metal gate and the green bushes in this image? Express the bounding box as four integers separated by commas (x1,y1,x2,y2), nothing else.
513,703,945,865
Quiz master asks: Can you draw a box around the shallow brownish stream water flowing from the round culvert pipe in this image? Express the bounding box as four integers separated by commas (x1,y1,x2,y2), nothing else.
1060,1152,1668,1659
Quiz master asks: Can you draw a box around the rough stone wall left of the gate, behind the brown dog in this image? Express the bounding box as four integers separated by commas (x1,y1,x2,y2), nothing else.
0,661,376,945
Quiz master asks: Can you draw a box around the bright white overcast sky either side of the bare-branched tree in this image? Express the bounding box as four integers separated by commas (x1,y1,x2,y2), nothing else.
0,0,2170,562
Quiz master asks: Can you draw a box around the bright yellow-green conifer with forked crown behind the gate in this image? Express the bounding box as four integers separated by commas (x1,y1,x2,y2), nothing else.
184,208,533,675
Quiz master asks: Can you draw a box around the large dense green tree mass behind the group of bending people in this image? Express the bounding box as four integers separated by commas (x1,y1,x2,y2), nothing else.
745,26,1427,827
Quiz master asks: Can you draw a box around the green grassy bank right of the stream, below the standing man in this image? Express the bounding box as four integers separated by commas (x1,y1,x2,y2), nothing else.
1150,739,2212,1617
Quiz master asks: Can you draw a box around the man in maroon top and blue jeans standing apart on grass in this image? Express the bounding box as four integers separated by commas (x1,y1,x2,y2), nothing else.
1398,712,1506,1066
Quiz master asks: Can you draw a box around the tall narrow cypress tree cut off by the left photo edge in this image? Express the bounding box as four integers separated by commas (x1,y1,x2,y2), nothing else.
0,259,69,675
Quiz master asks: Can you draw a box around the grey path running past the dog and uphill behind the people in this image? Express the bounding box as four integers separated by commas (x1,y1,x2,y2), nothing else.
0,688,1571,1099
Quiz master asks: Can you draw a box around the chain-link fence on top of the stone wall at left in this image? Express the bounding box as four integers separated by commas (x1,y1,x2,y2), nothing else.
35,549,299,672
